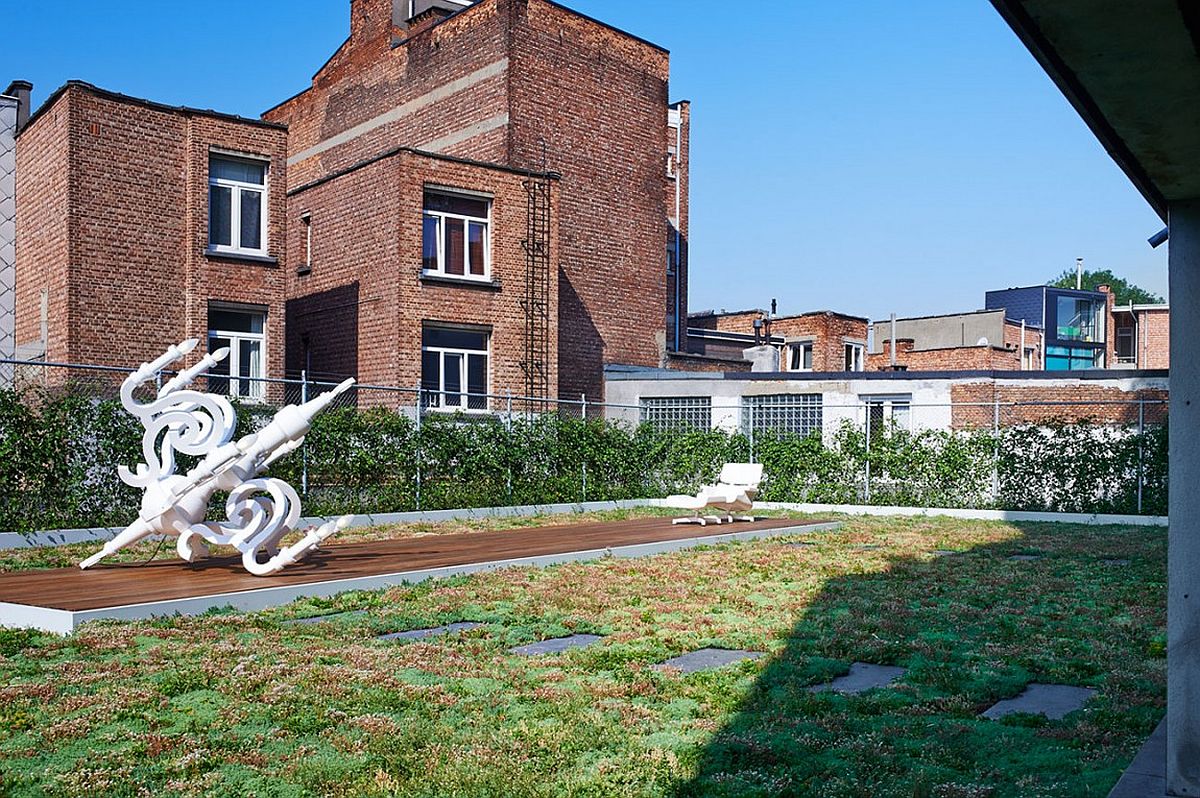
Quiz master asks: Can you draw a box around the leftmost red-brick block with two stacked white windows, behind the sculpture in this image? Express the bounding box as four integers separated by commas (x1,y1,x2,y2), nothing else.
16,82,287,396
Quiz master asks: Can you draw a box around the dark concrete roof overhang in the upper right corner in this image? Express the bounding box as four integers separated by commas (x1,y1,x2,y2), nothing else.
991,0,1200,221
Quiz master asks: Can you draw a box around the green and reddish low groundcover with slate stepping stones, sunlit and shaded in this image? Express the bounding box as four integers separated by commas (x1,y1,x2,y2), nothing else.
0,518,1166,798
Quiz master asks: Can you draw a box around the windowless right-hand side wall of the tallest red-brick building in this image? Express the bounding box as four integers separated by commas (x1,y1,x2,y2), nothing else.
509,0,673,397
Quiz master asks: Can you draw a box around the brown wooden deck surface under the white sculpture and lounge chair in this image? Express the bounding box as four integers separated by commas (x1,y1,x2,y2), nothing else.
0,518,812,609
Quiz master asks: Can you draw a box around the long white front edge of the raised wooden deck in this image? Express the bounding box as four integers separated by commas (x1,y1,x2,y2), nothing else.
0,522,841,634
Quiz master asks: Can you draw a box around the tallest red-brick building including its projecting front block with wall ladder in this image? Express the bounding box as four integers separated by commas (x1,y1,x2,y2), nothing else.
265,0,690,401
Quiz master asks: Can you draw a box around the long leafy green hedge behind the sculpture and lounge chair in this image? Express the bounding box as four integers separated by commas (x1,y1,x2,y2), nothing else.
0,391,1166,532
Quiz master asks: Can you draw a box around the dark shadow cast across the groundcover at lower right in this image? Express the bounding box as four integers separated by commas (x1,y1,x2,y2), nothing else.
677,524,1166,798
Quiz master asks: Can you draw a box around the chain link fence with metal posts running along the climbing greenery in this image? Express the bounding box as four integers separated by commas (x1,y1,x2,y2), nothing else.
0,361,1168,526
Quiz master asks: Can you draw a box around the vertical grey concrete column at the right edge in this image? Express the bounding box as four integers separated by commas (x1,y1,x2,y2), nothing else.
1166,199,1200,797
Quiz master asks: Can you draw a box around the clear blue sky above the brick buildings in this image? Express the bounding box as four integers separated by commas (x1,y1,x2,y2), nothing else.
0,0,1166,318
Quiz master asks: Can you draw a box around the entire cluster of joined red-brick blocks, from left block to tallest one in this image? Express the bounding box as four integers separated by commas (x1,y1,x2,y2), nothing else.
9,0,690,409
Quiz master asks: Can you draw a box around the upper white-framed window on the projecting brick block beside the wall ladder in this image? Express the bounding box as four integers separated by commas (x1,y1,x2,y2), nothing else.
421,191,492,280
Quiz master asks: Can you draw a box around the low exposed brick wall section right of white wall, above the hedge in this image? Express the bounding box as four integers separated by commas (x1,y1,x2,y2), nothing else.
950,380,1168,428
